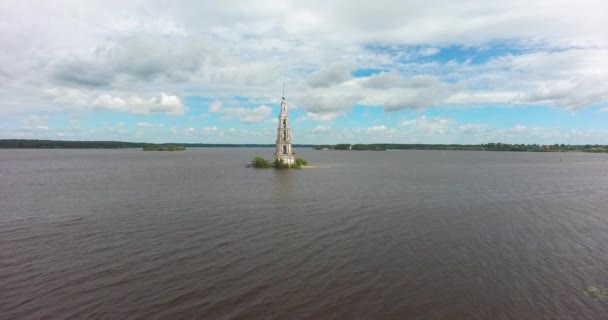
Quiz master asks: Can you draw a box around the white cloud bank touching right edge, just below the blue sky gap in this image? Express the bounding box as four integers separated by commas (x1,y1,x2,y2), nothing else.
458,48,608,109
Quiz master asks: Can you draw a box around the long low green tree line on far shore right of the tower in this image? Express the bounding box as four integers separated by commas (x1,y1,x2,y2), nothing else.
313,142,608,152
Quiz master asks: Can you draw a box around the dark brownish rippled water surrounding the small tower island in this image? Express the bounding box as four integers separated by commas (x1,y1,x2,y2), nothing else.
0,149,608,319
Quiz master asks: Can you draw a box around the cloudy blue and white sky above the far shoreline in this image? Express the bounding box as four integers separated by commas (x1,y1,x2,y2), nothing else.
0,0,608,144
